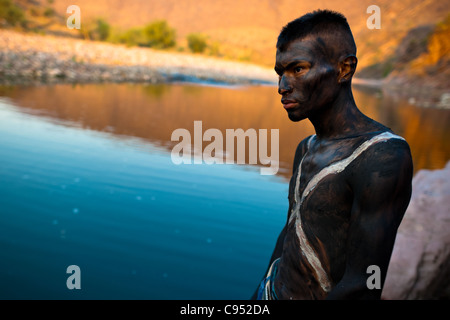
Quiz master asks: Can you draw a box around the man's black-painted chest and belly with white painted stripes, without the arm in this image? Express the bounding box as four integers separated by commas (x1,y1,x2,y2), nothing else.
275,132,406,299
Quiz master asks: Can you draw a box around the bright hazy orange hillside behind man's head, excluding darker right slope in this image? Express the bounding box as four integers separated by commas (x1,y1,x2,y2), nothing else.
2,0,450,69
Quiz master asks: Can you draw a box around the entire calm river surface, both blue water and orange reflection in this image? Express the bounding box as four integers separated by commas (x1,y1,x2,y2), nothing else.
0,84,450,299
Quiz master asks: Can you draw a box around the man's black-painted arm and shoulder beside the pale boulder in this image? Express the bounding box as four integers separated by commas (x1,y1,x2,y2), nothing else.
327,140,412,299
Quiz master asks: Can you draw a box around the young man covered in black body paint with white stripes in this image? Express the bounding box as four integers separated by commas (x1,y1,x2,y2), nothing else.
254,10,412,299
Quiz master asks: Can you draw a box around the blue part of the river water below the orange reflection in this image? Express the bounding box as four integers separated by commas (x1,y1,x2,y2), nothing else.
0,98,287,299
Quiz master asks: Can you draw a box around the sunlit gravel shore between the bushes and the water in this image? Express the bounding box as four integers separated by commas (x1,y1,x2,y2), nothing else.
0,30,277,84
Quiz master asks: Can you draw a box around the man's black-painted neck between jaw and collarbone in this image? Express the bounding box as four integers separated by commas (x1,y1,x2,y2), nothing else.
309,89,376,140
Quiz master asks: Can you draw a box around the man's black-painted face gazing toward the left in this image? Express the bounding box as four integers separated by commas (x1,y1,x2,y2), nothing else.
275,37,339,121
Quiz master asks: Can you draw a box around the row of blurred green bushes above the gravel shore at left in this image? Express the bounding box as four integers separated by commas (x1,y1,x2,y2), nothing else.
0,0,229,61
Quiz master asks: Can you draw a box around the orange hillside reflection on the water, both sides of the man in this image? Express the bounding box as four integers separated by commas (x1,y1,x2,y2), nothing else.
0,84,450,178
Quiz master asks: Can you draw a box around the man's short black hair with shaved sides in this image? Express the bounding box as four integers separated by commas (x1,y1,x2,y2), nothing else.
277,10,356,55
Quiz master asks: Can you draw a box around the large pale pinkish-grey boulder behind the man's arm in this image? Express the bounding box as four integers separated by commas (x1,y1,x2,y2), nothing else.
382,162,450,300
